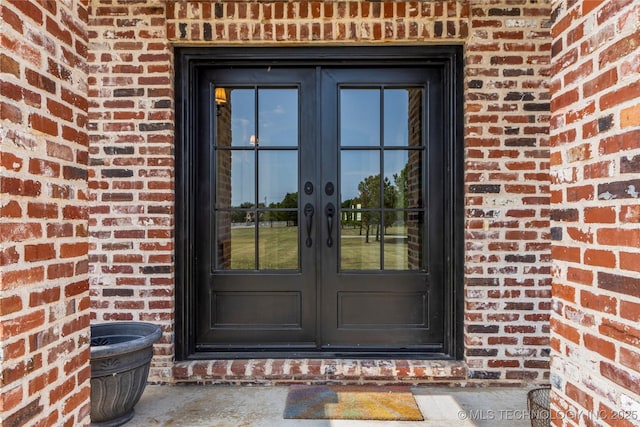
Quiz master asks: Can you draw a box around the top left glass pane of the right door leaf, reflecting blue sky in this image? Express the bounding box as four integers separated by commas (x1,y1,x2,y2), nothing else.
340,89,380,147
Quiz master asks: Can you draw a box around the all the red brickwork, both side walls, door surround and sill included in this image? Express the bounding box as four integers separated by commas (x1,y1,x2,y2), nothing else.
0,0,640,426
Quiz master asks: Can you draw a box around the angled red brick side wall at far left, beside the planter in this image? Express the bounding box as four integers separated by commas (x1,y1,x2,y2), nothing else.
0,0,90,427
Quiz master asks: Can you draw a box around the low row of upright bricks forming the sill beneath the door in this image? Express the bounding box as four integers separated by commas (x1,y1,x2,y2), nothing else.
173,358,468,385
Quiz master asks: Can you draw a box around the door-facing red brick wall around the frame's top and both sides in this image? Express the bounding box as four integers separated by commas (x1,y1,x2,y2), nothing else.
84,0,551,382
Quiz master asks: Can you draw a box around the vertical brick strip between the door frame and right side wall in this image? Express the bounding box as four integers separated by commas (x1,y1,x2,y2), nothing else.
464,1,551,382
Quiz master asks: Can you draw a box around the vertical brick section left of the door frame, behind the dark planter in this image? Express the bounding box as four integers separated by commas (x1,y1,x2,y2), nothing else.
88,0,174,380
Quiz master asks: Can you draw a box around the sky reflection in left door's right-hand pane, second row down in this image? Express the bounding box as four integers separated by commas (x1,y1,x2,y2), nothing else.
258,150,298,206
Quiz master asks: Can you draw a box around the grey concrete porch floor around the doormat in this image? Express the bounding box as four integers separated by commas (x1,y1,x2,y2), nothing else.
125,385,531,427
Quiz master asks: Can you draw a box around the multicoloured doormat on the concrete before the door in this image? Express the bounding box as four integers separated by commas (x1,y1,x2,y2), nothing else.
284,385,424,421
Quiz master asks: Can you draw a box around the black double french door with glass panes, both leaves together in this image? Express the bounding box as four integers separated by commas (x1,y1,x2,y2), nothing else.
176,47,464,357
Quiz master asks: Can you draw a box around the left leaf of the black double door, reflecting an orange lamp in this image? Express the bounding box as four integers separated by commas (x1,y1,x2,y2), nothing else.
195,67,317,351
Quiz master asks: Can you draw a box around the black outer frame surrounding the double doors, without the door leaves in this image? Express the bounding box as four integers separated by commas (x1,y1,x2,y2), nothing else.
174,45,464,360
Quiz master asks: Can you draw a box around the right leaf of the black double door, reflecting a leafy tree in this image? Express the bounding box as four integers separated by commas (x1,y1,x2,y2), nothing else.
320,68,444,350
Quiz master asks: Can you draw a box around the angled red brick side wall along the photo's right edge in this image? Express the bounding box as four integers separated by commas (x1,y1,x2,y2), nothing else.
551,0,640,426
